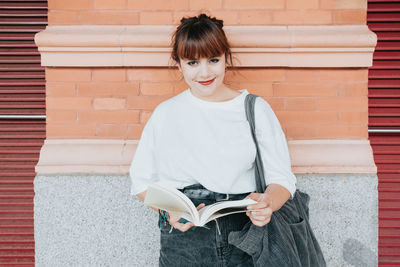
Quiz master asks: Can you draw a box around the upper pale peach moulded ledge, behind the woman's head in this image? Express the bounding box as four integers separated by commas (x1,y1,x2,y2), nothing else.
35,25,377,67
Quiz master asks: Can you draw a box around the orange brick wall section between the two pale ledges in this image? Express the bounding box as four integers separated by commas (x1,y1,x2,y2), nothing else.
46,68,368,139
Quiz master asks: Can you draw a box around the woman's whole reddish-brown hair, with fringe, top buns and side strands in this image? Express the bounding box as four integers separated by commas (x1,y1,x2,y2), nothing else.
171,13,233,67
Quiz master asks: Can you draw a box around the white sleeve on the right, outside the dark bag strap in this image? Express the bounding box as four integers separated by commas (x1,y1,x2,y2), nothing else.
255,97,297,198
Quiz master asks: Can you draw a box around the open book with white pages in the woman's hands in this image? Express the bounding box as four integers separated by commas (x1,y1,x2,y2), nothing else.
144,182,257,226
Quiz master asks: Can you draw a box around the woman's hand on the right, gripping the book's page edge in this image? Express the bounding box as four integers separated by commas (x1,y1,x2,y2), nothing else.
246,193,272,227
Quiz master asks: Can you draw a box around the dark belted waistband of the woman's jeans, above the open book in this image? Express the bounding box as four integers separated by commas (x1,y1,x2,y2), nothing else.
179,184,251,201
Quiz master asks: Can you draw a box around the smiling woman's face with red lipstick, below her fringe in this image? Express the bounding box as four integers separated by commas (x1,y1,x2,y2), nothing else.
178,54,225,100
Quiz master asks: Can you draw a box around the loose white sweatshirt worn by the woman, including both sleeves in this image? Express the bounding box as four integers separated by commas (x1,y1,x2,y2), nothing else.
129,89,296,198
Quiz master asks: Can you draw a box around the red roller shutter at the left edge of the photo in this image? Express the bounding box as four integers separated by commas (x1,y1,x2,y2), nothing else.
0,1,47,266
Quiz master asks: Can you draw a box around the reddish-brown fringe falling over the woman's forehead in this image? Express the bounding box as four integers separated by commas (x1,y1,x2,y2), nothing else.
177,24,227,60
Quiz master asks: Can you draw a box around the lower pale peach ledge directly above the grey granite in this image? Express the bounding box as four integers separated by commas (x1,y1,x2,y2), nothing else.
35,139,376,175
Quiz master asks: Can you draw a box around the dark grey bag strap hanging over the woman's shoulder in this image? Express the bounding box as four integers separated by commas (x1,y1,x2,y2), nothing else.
245,94,266,193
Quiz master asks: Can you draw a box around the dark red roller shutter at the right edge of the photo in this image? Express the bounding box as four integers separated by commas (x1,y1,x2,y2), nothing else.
367,0,400,266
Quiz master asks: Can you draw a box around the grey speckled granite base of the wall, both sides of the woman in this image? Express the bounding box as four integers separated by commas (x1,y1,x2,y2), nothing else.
34,174,378,267
